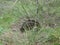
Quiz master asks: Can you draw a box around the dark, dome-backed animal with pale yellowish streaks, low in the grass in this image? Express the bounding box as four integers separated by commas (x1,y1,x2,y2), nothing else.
20,19,40,32
